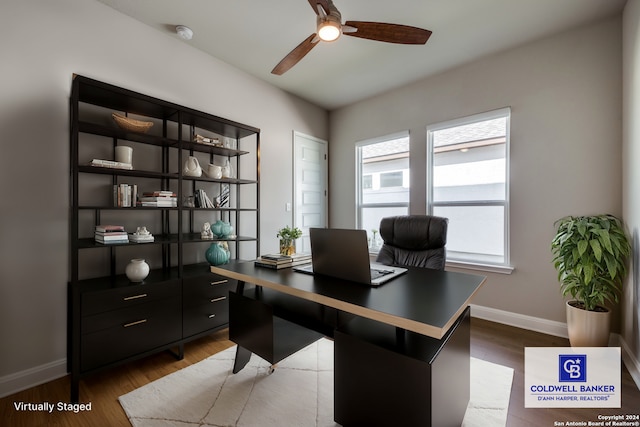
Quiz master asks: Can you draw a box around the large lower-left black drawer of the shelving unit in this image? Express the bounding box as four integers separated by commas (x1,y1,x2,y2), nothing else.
80,298,182,371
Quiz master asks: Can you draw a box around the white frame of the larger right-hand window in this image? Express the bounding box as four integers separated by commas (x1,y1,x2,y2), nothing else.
426,107,513,274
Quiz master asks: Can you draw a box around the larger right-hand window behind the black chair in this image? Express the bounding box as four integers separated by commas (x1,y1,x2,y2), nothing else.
427,108,511,266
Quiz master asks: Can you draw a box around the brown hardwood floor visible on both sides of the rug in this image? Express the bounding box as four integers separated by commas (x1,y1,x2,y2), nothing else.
0,318,640,427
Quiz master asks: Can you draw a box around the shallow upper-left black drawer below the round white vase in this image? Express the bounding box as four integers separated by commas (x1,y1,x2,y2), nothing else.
81,280,180,317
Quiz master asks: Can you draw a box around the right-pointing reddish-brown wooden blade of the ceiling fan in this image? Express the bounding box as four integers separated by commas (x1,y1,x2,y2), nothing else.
344,21,431,44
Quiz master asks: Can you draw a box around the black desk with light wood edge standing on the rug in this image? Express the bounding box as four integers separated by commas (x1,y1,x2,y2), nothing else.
211,261,486,426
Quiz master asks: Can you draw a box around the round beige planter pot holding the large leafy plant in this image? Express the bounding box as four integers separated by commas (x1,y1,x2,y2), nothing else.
567,301,611,347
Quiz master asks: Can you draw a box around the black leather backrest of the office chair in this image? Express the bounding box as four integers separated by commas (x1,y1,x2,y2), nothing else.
376,215,449,270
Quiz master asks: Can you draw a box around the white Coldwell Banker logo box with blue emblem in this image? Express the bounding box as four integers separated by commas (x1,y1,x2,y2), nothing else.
524,347,621,408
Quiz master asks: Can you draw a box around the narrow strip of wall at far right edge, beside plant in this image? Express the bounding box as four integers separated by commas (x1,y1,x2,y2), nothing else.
622,0,640,378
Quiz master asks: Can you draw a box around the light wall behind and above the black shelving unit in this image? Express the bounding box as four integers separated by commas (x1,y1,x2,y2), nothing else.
0,0,328,396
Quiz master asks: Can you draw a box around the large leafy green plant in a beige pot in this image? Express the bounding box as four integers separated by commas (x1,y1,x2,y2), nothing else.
551,215,631,347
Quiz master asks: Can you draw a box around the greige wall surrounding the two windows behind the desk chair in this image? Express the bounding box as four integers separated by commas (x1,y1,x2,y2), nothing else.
329,18,624,322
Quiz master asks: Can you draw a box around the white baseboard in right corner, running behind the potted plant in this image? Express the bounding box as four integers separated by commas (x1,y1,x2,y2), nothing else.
471,304,640,389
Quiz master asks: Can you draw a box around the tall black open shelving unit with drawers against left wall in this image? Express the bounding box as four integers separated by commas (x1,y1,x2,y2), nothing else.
67,75,260,402
